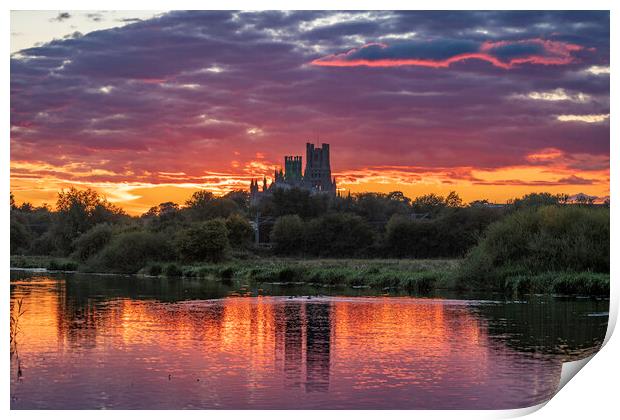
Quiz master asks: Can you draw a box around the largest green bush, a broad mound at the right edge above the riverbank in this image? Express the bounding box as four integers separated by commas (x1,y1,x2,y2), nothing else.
458,206,609,286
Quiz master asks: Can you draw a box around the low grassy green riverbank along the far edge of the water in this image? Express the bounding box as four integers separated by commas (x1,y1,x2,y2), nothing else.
11,255,609,296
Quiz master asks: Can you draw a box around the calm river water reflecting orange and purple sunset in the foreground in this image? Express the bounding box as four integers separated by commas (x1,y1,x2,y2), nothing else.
11,272,609,409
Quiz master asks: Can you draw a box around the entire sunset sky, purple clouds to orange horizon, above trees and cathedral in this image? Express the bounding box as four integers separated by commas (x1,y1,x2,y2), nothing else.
11,11,610,214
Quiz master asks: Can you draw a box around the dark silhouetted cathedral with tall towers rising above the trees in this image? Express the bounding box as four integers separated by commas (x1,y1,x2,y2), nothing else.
250,143,336,202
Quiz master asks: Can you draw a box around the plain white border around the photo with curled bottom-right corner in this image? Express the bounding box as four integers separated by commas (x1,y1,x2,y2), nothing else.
0,0,620,420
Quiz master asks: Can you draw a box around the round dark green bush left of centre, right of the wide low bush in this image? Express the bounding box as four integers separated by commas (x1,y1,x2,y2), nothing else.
176,219,230,262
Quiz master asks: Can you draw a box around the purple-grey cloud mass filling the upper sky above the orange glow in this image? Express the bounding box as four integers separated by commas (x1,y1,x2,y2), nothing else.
11,11,609,182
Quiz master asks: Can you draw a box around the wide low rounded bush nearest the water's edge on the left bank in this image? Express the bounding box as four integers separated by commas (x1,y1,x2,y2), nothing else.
86,231,175,273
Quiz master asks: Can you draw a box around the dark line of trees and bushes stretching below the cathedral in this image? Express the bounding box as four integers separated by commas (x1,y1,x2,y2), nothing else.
11,188,608,272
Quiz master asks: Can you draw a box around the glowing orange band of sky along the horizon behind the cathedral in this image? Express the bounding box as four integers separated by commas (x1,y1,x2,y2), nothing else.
11,158,609,215
